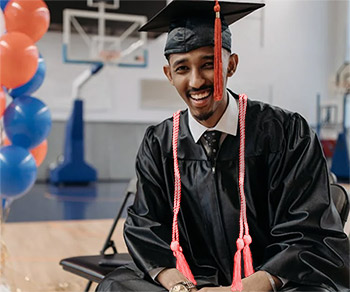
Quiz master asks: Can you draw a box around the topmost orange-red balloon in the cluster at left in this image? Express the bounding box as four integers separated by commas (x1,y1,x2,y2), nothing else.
4,0,50,43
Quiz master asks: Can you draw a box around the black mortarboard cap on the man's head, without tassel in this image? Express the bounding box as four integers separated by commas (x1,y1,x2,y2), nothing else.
140,0,265,55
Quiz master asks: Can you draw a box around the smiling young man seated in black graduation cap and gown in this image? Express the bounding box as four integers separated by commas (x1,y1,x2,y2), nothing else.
97,0,349,292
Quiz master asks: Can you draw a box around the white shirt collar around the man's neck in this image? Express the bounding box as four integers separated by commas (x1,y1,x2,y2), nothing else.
188,92,238,143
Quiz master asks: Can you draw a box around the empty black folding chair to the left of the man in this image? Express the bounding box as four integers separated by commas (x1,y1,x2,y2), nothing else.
60,178,136,292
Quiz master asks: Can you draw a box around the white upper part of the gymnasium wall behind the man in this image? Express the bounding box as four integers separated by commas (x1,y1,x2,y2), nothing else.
35,0,347,124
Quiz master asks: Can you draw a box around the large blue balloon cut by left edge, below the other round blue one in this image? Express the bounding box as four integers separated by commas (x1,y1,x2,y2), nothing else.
0,145,37,198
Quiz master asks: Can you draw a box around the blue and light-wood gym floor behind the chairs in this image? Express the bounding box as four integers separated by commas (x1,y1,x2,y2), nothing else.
0,181,350,292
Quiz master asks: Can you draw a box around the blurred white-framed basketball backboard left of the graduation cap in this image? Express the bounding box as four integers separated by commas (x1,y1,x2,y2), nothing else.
63,0,147,67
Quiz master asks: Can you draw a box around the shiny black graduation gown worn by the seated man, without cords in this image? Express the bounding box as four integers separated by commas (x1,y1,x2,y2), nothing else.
124,100,349,291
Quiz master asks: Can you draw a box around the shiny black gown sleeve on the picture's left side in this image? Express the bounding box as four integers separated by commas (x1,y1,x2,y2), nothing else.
124,127,176,275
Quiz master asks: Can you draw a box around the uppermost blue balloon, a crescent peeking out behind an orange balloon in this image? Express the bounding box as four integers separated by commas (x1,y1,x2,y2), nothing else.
9,55,46,98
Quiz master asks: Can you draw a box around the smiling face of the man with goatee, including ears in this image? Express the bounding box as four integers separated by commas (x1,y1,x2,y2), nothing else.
164,47,238,127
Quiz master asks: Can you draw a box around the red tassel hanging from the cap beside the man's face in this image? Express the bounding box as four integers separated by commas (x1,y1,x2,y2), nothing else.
214,1,223,101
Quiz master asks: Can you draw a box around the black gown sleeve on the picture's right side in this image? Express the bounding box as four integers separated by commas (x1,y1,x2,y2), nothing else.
260,114,349,291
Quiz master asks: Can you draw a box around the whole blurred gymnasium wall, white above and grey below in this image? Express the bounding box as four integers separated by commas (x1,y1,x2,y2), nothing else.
35,0,348,180
